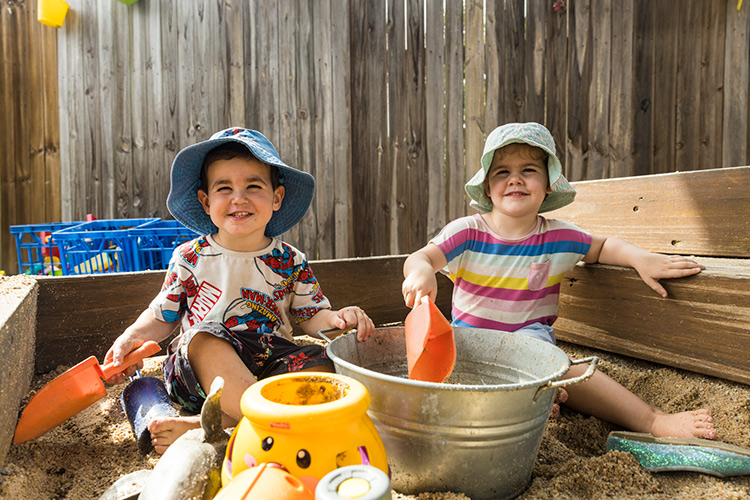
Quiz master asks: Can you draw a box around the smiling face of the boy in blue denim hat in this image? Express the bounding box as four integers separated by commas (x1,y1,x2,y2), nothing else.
198,157,284,251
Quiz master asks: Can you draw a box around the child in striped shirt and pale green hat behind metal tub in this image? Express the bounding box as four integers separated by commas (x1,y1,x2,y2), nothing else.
402,123,716,439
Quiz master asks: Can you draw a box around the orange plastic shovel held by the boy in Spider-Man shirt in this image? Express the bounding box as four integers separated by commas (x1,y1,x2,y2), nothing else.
13,341,160,444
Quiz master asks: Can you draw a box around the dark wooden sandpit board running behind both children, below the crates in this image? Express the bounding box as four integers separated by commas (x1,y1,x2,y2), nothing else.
35,255,452,373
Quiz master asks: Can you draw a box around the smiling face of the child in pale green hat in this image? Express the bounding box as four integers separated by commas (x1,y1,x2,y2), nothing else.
485,144,552,217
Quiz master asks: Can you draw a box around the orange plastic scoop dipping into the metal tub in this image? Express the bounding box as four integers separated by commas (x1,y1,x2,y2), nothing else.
405,297,456,382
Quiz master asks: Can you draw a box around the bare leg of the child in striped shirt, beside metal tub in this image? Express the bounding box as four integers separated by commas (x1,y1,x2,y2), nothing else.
563,365,716,439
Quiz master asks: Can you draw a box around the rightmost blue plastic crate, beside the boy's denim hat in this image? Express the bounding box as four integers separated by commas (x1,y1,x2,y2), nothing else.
128,220,199,271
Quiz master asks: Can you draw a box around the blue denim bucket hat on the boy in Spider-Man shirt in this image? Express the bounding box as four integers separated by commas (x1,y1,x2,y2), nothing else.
167,127,315,238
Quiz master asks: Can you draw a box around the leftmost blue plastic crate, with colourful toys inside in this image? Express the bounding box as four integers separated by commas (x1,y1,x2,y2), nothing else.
10,221,83,275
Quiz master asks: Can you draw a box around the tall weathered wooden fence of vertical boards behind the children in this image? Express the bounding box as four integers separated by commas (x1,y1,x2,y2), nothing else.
0,0,750,271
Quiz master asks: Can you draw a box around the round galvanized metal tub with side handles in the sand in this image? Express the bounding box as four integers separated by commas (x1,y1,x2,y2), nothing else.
326,327,599,500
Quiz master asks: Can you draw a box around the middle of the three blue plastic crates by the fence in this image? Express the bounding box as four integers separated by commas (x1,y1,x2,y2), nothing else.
53,218,159,275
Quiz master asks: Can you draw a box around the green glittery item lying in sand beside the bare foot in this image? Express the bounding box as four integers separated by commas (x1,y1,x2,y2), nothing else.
607,431,750,477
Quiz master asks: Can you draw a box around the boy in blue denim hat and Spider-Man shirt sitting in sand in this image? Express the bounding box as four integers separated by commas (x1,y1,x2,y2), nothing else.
105,128,374,453
